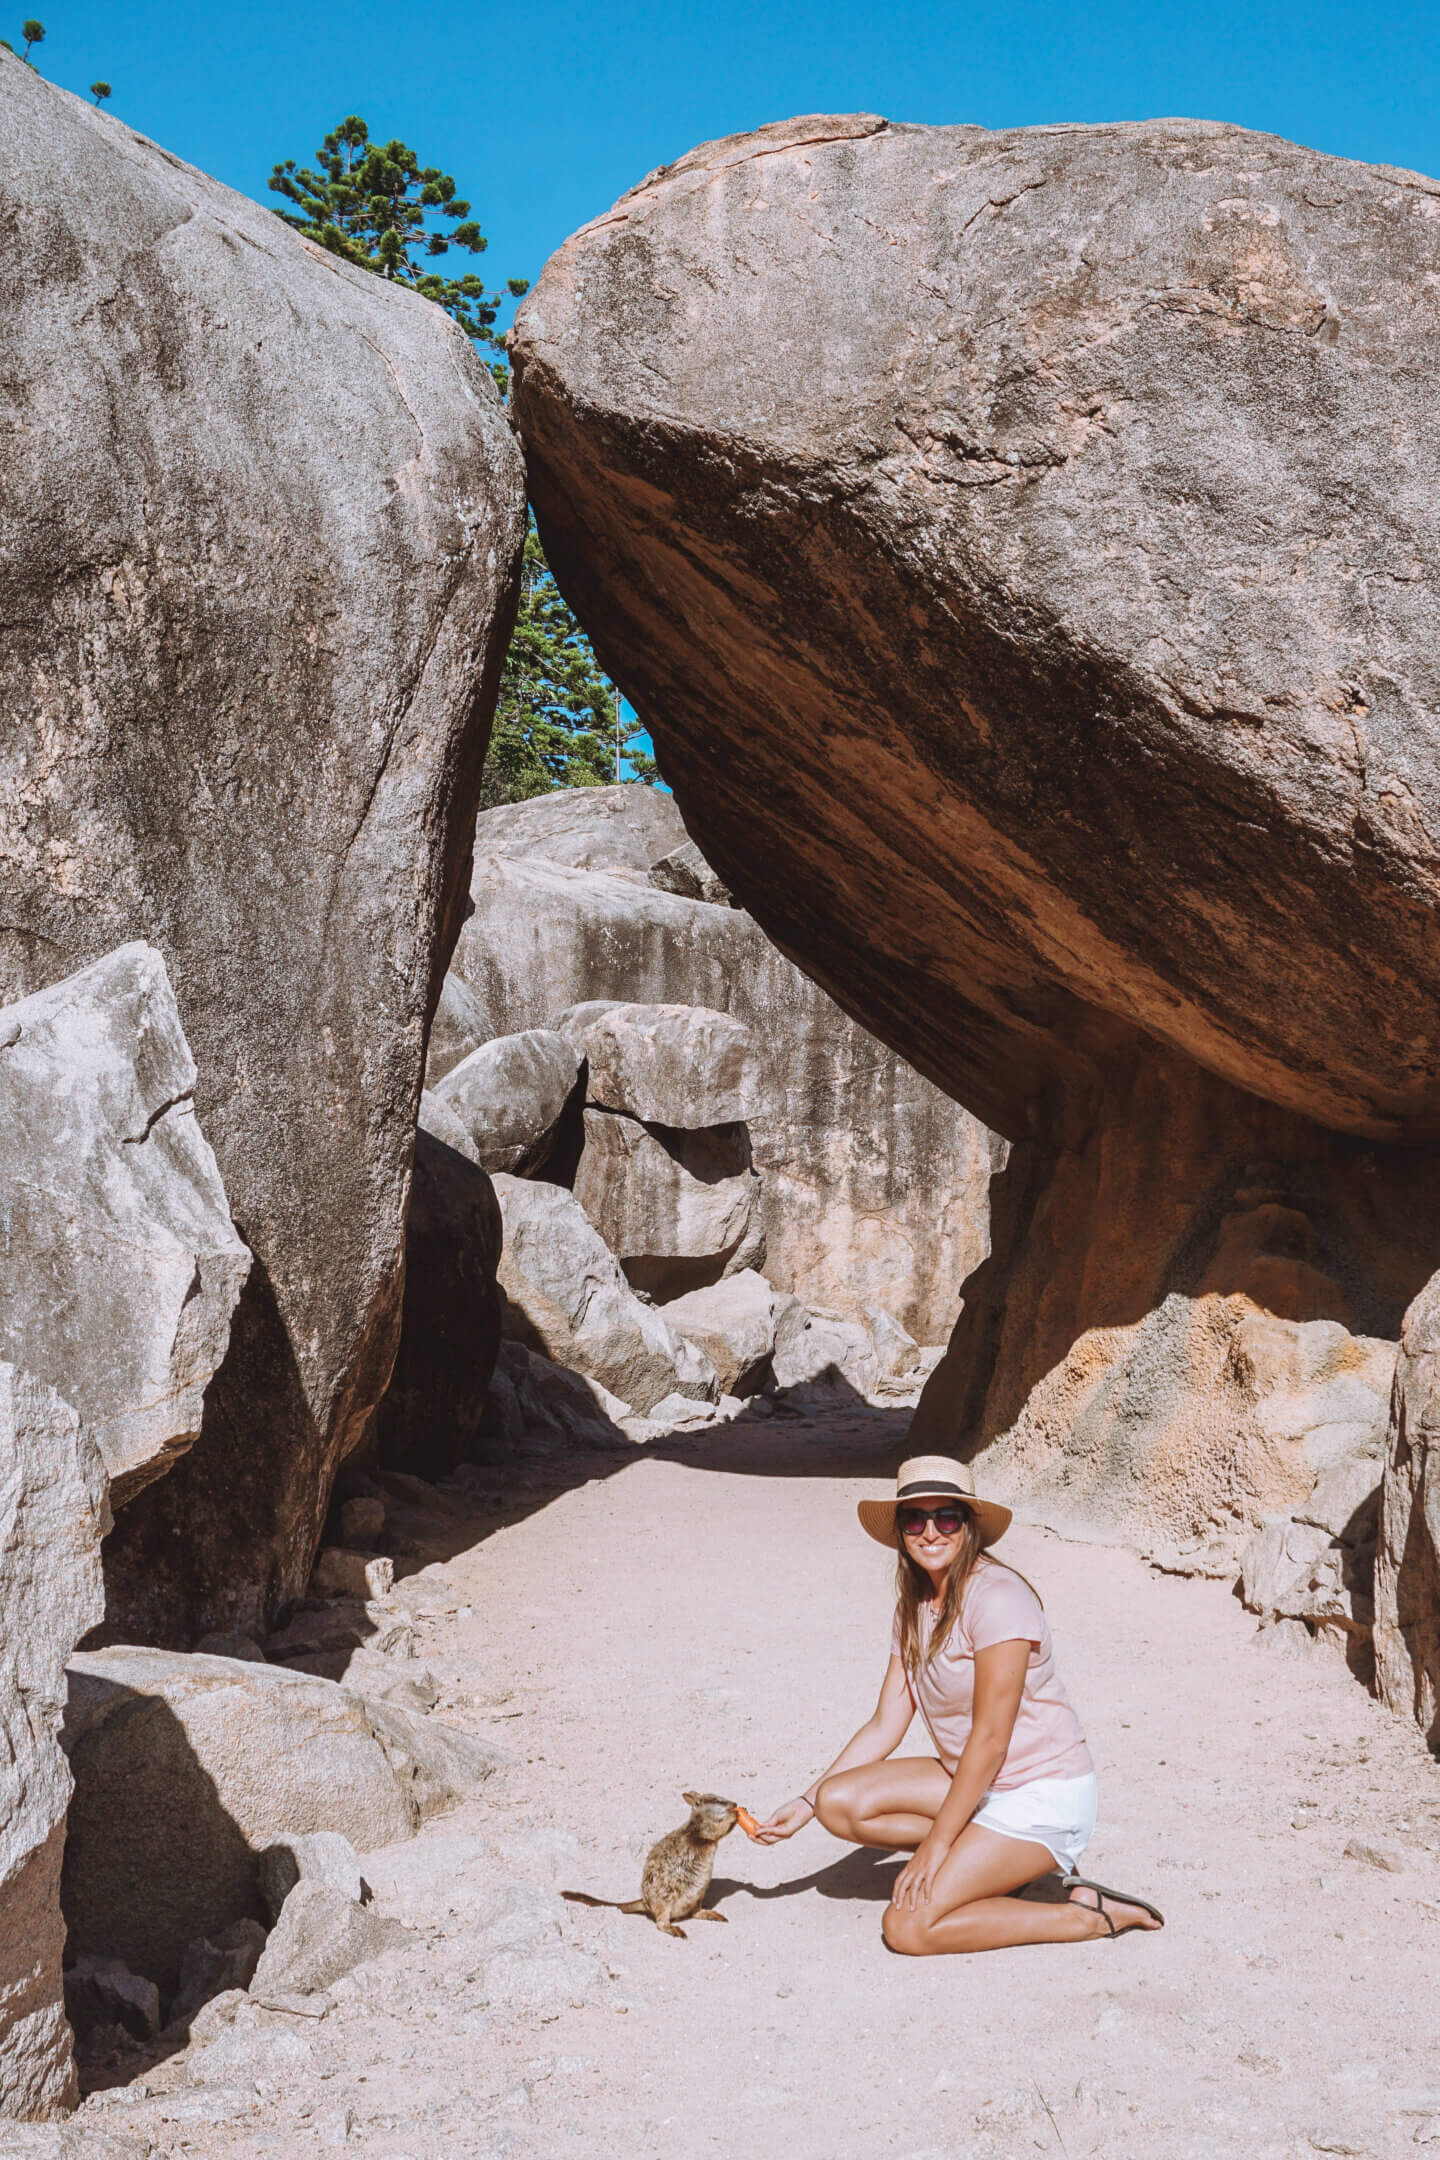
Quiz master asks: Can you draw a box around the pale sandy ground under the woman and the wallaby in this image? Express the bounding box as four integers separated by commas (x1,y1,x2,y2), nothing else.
80,1413,1440,2160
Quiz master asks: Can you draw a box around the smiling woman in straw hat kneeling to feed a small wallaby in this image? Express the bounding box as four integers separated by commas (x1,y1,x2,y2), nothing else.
760,1456,1164,1957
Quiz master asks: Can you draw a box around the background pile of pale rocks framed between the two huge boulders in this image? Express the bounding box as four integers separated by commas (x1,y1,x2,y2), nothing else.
377,784,984,1477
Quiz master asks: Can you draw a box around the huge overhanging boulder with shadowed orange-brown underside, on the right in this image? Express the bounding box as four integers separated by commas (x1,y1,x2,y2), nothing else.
515,114,1440,1607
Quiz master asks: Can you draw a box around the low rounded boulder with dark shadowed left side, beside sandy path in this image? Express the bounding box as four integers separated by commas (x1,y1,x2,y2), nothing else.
63,1648,421,1994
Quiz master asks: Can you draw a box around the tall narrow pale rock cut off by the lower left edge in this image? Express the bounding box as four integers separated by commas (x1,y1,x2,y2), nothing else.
0,1365,110,2117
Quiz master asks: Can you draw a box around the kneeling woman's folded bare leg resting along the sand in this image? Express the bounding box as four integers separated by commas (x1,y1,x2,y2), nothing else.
881,1823,1136,1957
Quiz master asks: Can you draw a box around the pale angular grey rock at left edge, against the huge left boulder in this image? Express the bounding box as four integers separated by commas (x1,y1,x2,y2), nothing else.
0,944,250,1508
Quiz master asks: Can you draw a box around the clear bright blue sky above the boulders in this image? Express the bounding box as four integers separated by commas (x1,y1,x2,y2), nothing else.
22,0,1440,334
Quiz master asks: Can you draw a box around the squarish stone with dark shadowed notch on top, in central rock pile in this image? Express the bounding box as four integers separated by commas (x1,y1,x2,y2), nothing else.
574,1110,764,1302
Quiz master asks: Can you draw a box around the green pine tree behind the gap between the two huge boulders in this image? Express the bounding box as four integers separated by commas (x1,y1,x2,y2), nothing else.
273,113,656,808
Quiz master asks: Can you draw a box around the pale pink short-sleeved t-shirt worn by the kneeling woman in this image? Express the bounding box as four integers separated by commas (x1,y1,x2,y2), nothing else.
889,1560,1095,1793
